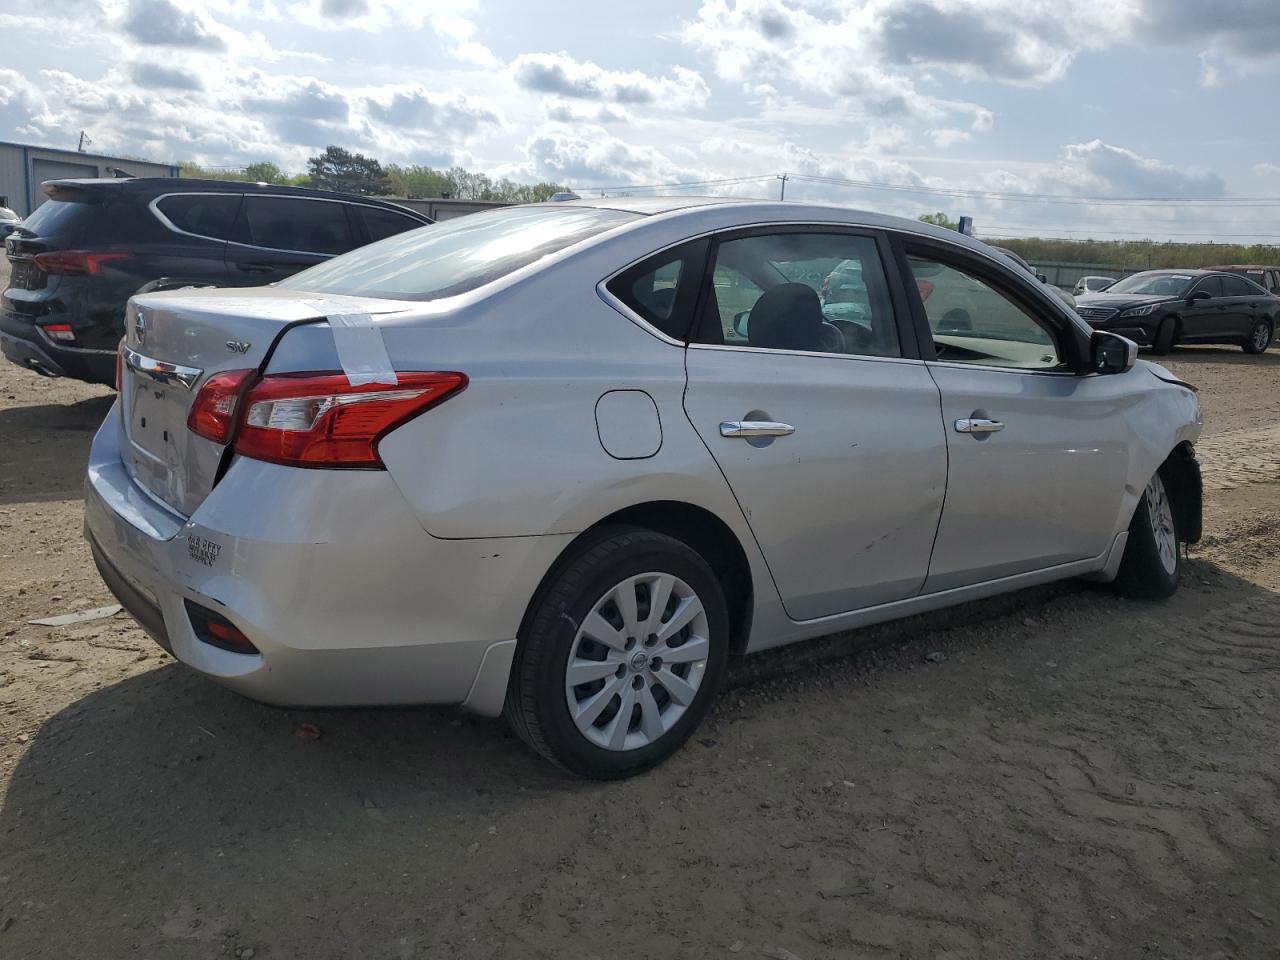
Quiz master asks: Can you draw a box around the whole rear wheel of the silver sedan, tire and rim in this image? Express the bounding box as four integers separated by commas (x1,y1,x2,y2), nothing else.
503,529,730,780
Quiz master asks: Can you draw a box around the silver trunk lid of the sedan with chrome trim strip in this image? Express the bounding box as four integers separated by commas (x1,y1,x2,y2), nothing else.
120,287,403,517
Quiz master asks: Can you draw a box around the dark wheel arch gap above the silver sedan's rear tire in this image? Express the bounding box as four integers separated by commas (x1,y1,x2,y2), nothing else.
520,500,754,653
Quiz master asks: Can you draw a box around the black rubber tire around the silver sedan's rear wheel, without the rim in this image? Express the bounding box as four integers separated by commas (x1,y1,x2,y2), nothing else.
517,531,730,780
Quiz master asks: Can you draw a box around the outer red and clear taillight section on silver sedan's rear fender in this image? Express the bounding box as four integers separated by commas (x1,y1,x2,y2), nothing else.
232,372,467,468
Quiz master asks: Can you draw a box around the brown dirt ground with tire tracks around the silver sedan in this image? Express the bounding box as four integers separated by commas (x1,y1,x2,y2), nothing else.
0,295,1280,960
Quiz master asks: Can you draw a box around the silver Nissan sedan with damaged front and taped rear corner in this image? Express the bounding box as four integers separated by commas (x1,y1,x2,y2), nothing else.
86,197,1201,777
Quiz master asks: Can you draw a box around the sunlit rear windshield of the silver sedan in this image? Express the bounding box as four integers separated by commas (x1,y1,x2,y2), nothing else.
278,206,639,300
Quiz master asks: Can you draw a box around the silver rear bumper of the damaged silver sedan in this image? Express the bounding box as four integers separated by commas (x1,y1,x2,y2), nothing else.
84,406,570,716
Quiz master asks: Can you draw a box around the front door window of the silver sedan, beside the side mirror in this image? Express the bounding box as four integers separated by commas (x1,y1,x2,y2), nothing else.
910,257,1062,370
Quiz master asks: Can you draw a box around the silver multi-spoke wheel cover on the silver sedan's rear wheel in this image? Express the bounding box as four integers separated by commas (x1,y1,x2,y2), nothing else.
564,572,710,750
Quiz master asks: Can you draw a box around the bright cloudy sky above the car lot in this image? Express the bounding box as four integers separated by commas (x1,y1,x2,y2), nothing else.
0,0,1280,244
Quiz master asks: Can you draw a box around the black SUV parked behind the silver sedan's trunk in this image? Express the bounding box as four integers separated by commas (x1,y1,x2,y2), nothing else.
0,178,431,384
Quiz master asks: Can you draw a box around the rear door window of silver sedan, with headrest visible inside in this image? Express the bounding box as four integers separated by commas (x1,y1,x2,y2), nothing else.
698,233,902,357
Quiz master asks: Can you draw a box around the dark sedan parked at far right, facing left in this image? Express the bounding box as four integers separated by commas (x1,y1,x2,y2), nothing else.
1075,270,1280,353
